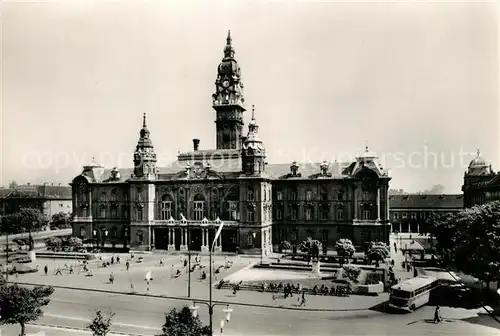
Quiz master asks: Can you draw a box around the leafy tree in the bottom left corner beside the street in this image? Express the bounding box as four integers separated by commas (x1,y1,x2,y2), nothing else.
0,284,54,336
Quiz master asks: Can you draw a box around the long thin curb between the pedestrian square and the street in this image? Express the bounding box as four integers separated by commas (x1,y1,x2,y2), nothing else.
11,282,371,312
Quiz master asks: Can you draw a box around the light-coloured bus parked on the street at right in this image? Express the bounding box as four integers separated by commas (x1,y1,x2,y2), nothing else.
389,275,439,312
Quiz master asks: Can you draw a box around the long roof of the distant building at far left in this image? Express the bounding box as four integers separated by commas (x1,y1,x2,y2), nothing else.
0,185,72,200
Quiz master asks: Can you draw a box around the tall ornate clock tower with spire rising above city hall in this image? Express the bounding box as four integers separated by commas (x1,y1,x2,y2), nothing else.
212,32,245,150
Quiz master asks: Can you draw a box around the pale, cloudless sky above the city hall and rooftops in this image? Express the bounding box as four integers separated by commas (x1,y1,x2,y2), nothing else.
0,0,500,193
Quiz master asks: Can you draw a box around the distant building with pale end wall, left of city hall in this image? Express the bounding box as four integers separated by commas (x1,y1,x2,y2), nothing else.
0,184,73,219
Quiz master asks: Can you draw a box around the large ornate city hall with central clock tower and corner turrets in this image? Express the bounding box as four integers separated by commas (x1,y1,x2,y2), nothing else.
71,35,391,256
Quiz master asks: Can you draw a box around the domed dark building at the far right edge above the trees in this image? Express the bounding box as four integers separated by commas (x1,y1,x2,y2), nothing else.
462,150,500,208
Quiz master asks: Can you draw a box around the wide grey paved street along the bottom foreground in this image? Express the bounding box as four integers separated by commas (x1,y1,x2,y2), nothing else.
2,289,500,336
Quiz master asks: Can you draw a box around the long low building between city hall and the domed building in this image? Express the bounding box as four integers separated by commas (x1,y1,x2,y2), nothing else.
389,194,463,233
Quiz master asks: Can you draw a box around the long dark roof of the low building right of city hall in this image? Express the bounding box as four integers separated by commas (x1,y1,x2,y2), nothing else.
389,194,464,209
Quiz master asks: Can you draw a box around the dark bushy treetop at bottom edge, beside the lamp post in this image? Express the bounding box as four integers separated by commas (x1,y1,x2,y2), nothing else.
157,306,210,336
